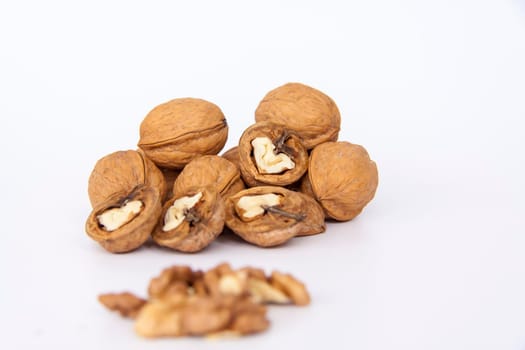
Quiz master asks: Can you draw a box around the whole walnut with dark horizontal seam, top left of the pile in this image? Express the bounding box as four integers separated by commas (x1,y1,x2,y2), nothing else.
138,98,228,169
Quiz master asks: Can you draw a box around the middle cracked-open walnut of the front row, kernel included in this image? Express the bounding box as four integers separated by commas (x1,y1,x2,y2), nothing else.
152,187,224,253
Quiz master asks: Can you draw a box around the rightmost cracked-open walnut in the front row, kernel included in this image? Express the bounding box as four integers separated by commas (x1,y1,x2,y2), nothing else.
222,186,325,247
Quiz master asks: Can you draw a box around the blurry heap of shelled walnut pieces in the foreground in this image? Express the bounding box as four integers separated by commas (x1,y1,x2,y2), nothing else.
98,263,310,338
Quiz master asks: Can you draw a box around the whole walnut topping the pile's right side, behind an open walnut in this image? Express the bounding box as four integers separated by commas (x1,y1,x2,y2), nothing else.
255,83,341,149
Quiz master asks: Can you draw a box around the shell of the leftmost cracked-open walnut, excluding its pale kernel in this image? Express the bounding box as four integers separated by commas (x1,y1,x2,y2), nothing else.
86,185,162,253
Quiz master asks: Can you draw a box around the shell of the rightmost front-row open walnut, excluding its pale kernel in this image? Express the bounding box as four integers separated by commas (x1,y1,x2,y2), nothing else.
226,186,325,247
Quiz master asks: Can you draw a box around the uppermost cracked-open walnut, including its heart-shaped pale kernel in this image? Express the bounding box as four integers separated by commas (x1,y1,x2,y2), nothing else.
238,122,308,187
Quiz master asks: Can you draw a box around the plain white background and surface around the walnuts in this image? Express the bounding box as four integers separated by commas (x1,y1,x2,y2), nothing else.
0,0,525,350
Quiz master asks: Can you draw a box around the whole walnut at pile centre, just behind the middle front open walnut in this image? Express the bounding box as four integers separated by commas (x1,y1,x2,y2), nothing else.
173,156,244,198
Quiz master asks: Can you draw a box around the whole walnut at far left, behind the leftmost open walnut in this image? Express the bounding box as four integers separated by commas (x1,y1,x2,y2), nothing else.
88,150,166,208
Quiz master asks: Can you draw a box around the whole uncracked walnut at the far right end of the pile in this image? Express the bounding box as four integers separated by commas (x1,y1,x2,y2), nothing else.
308,142,378,221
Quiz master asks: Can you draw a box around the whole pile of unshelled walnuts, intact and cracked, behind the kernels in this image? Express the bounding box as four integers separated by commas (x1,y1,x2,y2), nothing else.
86,83,378,253
